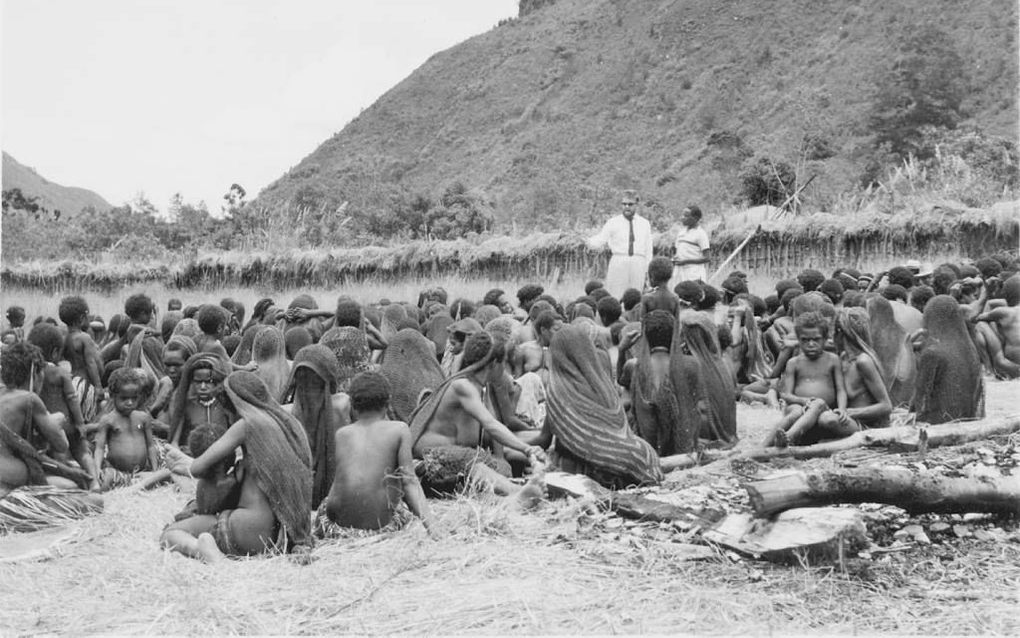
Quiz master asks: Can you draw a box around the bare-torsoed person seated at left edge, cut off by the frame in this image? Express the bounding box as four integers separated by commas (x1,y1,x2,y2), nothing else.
0,342,68,497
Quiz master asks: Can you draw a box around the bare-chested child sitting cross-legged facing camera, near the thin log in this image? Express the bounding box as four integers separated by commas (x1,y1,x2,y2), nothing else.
765,311,848,447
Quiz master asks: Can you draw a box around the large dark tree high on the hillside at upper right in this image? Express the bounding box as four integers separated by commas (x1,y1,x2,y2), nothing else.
869,27,968,159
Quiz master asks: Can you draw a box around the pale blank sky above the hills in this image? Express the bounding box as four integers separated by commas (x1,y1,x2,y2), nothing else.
0,0,517,213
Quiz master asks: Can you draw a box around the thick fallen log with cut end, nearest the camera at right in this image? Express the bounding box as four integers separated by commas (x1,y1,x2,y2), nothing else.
744,468,1020,517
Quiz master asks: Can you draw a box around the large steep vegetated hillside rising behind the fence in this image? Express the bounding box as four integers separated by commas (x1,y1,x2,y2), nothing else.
254,0,1018,231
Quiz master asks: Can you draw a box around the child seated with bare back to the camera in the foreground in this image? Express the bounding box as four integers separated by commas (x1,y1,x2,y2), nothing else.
314,373,432,537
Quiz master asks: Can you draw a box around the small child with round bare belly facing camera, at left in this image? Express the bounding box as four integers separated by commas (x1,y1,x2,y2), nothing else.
95,367,159,481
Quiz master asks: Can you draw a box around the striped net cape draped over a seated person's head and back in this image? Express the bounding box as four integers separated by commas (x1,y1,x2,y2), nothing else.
546,326,662,486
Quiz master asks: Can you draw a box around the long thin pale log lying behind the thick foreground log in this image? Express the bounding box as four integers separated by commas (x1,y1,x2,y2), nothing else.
733,414,1020,460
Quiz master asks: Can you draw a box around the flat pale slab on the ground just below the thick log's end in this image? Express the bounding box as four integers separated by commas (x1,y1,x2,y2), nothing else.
702,507,868,565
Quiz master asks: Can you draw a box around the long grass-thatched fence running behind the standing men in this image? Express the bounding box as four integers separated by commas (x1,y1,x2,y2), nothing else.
0,202,1020,291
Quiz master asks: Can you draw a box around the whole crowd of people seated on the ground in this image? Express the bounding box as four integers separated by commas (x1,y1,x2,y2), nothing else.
0,254,1020,562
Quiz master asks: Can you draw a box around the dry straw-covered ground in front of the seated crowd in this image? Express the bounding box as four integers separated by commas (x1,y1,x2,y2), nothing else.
0,382,1020,635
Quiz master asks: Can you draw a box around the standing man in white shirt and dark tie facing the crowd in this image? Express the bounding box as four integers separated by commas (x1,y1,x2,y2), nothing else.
588,190,652,298
